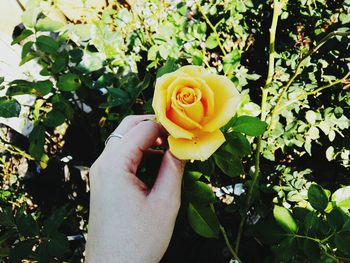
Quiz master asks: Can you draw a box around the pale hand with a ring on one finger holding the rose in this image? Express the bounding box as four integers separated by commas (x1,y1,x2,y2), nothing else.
86,115,184,263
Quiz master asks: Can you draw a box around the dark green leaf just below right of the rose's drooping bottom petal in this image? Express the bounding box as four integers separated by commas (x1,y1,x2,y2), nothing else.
213,150,243,177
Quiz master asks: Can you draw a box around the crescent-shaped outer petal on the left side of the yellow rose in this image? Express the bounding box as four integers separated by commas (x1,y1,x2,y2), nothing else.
152,73,193,139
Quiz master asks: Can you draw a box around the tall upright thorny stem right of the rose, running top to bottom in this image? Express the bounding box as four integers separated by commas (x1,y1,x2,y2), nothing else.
235,0,284,254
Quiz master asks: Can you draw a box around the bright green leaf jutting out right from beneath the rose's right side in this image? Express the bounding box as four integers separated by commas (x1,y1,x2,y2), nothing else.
232,115,267,136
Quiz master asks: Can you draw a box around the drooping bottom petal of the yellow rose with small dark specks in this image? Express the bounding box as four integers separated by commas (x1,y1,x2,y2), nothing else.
168,130,225,161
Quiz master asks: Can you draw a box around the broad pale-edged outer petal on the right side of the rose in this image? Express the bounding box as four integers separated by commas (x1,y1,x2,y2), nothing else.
203,74,241,132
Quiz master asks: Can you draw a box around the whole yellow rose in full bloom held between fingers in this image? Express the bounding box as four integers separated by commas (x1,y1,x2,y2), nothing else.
152,66,240,161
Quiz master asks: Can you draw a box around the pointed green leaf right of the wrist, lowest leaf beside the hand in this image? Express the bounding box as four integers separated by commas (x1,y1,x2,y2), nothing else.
187,203,220,238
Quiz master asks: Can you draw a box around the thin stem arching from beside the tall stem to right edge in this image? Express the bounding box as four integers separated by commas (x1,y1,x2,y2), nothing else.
268,31,350,130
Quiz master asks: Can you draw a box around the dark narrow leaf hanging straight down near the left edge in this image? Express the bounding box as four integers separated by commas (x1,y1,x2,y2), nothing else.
29,124,45,161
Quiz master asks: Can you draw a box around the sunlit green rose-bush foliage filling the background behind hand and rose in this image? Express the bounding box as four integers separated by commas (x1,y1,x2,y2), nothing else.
0,0,350,262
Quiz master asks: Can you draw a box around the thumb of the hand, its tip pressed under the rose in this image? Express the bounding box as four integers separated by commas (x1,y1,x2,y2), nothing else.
150,151,185,202
